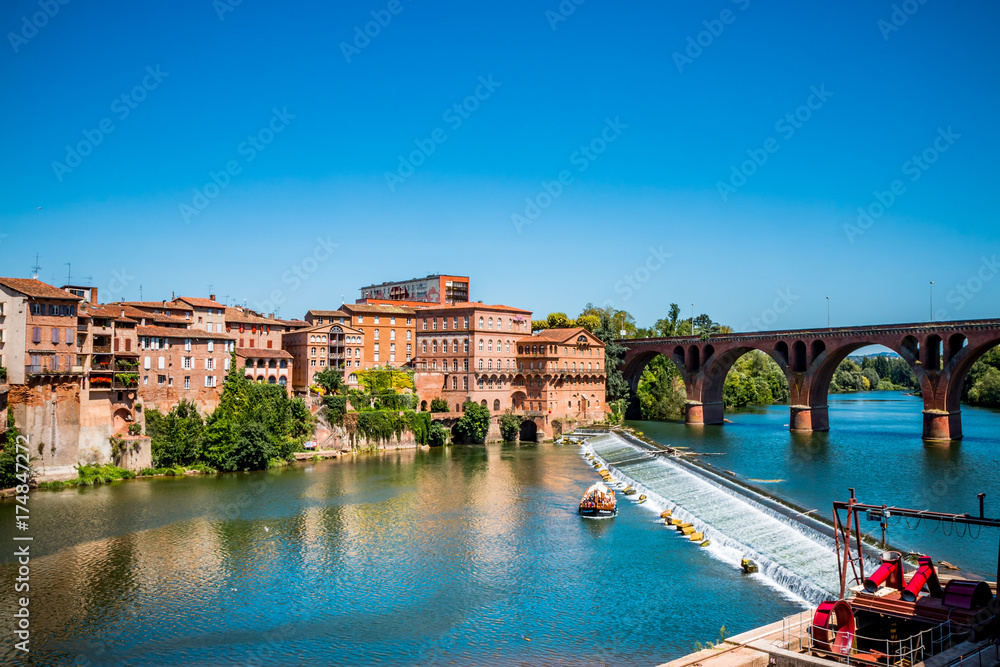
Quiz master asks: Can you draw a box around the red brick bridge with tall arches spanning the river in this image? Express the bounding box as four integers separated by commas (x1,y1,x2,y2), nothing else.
618,320,1000,440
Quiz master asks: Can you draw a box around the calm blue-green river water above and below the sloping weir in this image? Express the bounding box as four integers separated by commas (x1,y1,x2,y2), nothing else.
0,394,1000,665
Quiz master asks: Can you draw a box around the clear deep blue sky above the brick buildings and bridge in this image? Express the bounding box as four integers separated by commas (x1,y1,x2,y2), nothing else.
0,0,1000,329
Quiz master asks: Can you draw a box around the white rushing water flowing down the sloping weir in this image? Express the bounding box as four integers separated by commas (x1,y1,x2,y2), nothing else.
583,434,856,603
